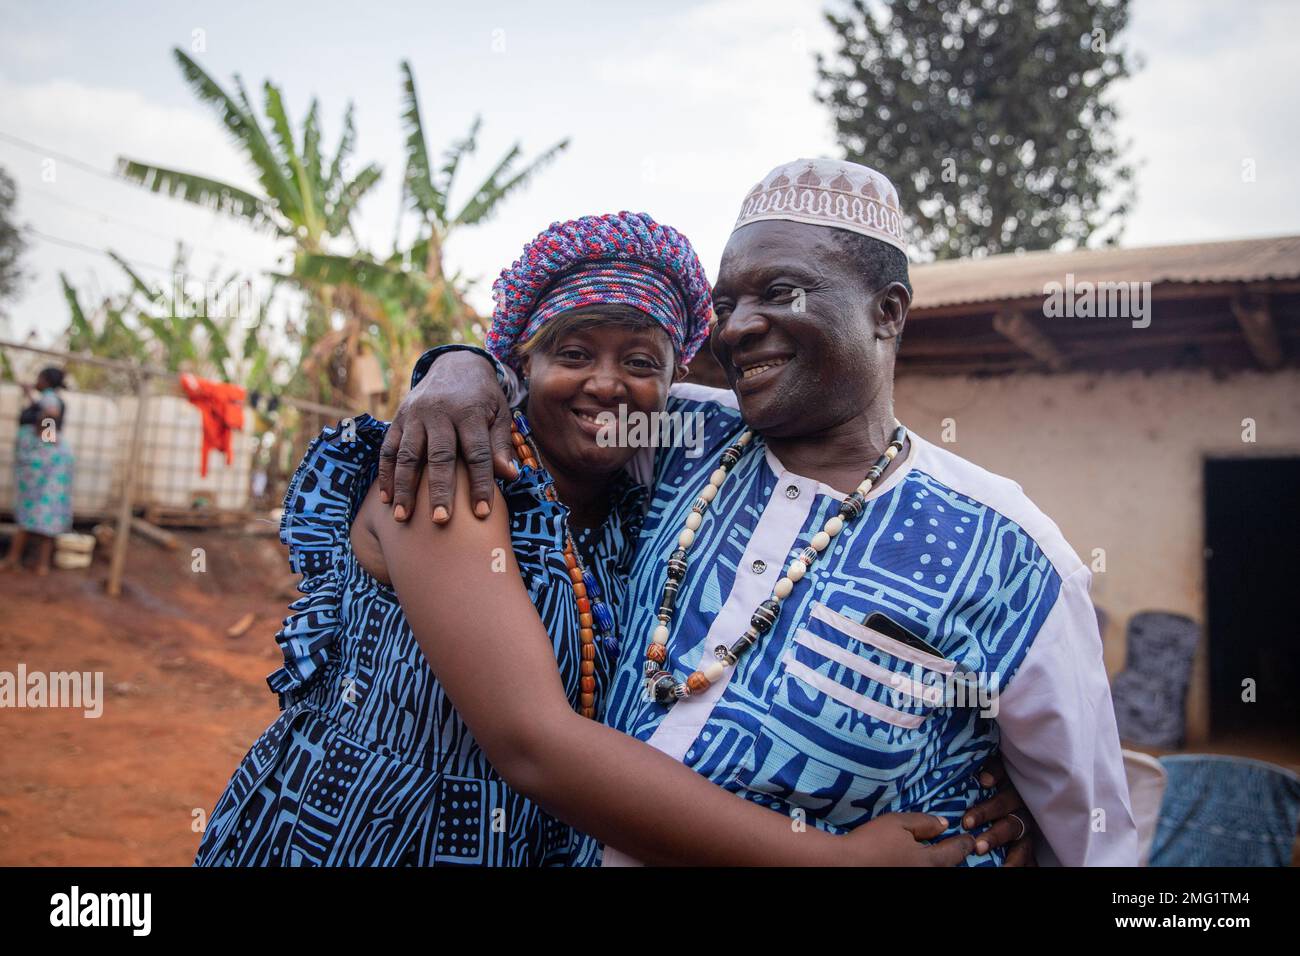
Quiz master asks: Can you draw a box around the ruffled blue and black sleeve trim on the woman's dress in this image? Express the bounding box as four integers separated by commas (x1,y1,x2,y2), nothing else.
267,415,389,706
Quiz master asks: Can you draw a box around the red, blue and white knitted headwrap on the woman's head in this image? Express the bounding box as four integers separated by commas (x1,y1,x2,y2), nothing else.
488,212,712,367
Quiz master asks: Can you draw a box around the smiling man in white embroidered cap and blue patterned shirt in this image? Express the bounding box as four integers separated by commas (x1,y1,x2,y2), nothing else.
387,159,1136,865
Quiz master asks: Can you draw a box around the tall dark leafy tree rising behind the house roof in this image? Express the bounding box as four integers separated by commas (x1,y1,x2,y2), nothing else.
818,0,1134,259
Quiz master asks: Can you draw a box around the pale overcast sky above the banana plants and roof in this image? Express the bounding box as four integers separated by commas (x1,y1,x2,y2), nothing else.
0,0,1300,341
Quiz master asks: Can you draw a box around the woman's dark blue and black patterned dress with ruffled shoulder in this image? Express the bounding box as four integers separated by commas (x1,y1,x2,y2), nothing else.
195,415,645,866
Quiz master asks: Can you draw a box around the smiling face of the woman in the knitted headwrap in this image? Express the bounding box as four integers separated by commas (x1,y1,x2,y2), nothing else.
523,310,675,476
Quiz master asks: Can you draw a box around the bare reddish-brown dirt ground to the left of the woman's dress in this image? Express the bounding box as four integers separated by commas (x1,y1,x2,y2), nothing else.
0,531,289,866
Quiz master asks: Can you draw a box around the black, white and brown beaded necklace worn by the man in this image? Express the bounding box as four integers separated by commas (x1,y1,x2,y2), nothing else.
645,421,907,705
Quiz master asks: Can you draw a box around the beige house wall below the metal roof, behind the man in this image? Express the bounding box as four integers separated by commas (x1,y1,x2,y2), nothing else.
896,369,1300,745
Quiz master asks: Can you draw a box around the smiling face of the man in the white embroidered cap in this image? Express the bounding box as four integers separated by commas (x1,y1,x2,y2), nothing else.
712,220,910,438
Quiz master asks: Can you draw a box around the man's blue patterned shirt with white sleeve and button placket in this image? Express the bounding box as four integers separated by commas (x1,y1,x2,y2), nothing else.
605,385,1136,865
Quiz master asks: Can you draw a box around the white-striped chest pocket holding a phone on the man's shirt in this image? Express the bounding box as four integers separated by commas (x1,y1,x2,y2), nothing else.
735,602,954,826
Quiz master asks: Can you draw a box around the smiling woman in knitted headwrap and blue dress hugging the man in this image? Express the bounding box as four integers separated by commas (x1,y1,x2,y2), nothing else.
198,213,972,865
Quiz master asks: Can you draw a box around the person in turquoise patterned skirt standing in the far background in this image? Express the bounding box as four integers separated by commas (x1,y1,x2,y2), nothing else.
0,368,73,575
